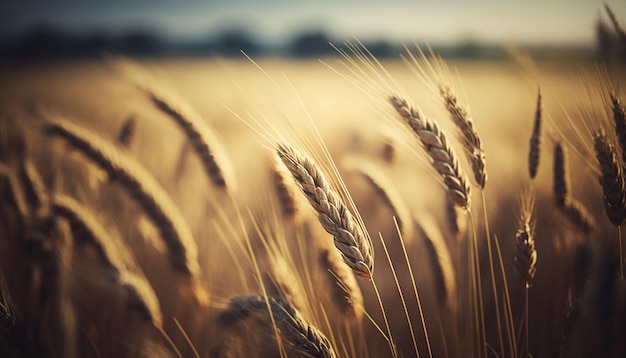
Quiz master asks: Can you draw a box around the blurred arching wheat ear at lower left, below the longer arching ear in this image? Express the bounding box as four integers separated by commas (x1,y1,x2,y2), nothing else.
52,194,163,327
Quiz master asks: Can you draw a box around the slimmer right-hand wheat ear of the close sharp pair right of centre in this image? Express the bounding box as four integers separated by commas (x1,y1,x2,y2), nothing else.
439,85,487,189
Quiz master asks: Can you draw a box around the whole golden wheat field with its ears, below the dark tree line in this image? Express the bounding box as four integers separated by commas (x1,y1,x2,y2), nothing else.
0,39,626,358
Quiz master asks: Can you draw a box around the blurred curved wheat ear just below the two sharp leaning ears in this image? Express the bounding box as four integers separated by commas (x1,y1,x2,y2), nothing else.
415,213,456,308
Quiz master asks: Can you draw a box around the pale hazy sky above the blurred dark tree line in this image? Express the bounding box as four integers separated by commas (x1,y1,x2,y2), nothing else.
0,0,626,45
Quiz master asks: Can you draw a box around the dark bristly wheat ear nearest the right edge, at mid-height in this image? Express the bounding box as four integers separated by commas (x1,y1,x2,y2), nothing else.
594,133,626,226
